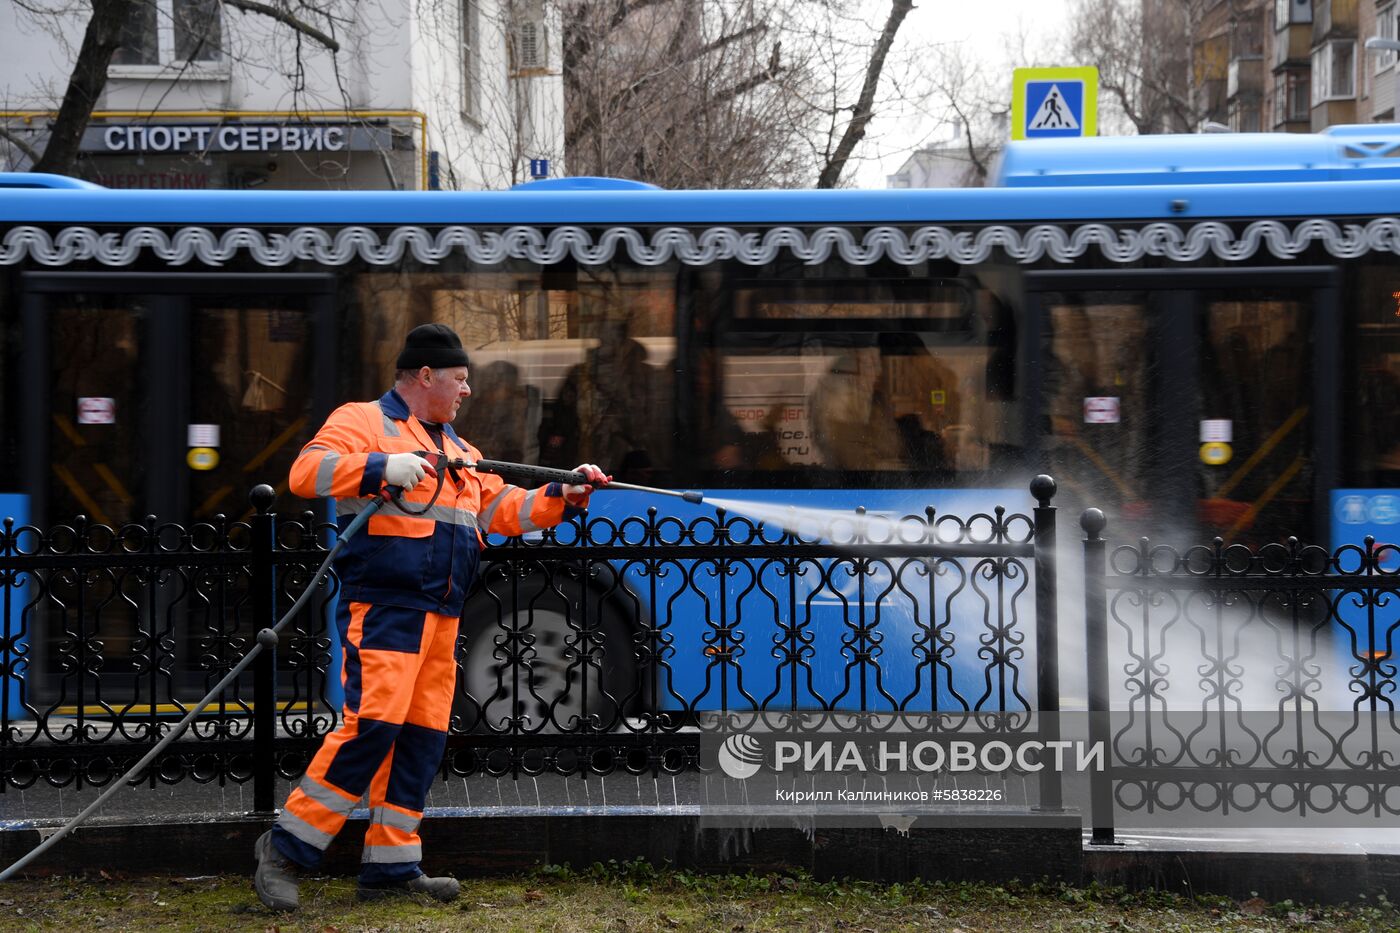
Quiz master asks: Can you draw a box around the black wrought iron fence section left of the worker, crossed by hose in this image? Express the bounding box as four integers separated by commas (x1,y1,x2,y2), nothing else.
0,486,336,806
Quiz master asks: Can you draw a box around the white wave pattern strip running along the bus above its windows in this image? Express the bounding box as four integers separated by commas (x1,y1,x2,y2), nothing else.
0,217,1400,266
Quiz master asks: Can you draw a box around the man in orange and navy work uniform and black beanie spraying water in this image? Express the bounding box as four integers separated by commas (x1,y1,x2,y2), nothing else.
253,324,609,911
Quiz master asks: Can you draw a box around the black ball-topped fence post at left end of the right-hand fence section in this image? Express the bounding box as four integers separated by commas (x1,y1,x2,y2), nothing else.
1079,509,1113,846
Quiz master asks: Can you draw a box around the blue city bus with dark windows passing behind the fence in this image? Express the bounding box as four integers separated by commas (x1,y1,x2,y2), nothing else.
0,125,1400,714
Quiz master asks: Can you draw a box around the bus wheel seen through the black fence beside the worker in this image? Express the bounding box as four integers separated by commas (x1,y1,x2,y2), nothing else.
452,565,644,733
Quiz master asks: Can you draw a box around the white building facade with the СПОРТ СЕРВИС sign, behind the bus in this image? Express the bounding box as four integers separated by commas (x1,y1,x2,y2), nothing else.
0,0,564,189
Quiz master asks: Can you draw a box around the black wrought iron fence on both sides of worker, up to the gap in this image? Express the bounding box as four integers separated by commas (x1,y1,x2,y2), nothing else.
0,476,1058,810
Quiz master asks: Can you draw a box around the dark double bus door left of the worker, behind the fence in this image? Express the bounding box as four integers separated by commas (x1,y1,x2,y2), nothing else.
21,273,336,700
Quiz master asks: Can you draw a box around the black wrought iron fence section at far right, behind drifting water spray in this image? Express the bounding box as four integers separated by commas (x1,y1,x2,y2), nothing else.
1081,509,1400,842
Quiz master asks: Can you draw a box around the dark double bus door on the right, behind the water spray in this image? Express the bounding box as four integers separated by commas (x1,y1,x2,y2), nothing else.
1022,268,1340,545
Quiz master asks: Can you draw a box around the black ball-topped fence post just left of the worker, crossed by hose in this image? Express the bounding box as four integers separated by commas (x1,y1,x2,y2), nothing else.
248,485,277,814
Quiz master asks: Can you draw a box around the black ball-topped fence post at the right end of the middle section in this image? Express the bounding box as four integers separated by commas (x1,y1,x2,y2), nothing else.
1030,474,1064,810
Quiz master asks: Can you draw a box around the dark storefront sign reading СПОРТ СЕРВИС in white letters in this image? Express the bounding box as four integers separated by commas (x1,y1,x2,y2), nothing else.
81,123,393,154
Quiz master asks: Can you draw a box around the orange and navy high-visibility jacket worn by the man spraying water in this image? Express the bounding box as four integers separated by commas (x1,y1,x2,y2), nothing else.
291,389,581,615
